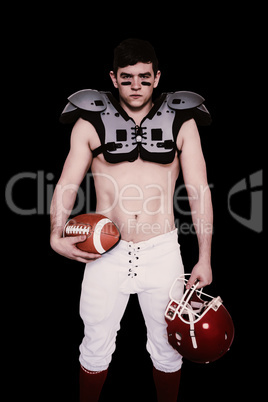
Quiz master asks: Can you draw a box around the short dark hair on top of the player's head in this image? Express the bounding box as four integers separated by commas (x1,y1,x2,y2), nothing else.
113,39,158,75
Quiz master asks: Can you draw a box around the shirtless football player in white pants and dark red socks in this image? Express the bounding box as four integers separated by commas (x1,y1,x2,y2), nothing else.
51,40,213,402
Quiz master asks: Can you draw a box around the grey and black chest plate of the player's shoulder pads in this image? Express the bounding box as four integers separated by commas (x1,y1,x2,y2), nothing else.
98,94,176,164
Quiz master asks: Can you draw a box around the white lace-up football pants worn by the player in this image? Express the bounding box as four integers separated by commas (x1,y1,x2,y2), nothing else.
80,230,184,372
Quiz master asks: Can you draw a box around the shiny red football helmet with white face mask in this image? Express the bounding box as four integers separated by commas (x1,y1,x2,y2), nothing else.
165,274,234,363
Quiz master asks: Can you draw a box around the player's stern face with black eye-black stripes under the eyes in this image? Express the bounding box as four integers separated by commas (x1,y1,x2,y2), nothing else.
110,63,160,109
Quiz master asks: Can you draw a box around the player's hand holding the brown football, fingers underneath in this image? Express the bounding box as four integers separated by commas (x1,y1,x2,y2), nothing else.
50,234,101,264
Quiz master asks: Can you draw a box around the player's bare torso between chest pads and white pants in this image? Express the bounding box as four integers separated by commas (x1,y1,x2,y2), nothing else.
90,129,179,242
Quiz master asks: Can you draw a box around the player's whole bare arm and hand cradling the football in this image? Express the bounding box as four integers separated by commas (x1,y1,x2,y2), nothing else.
50,119,99,263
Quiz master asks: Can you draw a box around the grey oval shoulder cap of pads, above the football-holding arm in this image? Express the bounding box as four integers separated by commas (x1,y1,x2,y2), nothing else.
68,89,107,112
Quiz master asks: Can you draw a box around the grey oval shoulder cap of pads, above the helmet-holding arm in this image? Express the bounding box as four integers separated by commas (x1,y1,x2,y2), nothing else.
167,91,205,110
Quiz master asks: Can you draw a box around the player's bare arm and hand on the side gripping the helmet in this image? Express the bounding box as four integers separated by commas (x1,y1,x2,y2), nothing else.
178,120,213,288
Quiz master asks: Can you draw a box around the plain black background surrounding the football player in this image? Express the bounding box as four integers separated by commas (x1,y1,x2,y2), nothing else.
5,8,263,402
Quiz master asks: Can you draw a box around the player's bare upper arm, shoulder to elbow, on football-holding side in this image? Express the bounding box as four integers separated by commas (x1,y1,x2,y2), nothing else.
60,119,92,186
